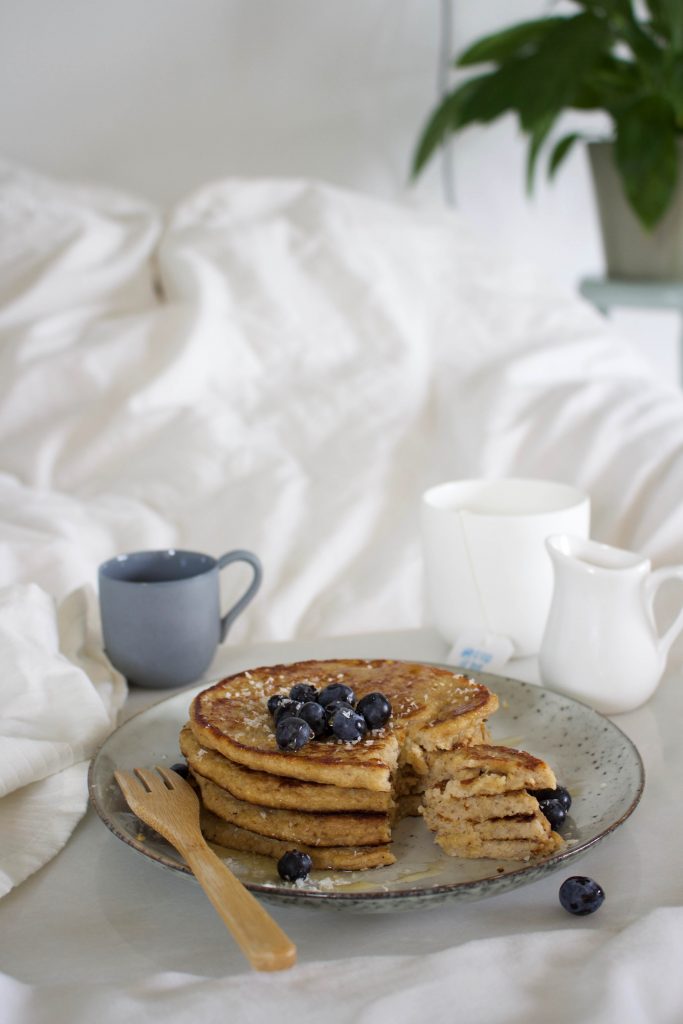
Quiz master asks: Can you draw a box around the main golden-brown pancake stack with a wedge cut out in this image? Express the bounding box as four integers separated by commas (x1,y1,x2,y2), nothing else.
180,660,565,869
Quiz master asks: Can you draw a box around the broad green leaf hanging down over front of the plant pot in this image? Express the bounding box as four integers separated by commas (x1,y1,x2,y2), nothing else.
614,96,678,229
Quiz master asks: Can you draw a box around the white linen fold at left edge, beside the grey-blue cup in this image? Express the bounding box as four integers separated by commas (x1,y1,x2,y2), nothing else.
0,584,126,896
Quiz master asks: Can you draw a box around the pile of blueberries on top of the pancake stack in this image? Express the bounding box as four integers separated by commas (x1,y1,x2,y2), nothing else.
268,683,391,751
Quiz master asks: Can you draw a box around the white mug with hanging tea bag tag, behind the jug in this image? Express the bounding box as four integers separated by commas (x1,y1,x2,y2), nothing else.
421,477,590,657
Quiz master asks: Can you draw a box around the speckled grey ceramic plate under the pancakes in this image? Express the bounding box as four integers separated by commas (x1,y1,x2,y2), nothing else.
89,673,644,912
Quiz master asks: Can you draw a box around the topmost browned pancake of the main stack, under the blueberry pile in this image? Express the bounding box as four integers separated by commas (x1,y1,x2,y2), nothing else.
189,659,498,793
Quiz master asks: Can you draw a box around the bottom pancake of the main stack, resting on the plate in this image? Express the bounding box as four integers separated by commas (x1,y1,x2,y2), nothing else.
202,809,396,871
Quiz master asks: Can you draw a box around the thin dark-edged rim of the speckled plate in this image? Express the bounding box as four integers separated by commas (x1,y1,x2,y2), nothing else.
87,657,646,905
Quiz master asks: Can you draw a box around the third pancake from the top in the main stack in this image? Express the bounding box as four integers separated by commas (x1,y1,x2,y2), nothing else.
195,775,391,846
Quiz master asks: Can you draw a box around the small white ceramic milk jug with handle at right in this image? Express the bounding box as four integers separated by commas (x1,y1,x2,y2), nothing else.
539,534,683,715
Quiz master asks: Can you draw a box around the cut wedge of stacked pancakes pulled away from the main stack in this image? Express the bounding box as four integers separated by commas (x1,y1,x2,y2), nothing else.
421,745,563,860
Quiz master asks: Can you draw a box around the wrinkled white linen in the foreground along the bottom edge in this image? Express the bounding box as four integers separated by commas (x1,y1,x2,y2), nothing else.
0,907,683,1024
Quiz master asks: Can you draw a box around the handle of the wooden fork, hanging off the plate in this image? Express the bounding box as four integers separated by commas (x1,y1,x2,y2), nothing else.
180,839,296,971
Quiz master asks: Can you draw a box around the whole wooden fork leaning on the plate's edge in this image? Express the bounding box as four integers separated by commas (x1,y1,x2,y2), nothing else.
114,765,296,971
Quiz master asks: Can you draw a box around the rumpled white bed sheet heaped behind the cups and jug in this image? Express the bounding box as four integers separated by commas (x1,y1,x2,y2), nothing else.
0,158,683,640
